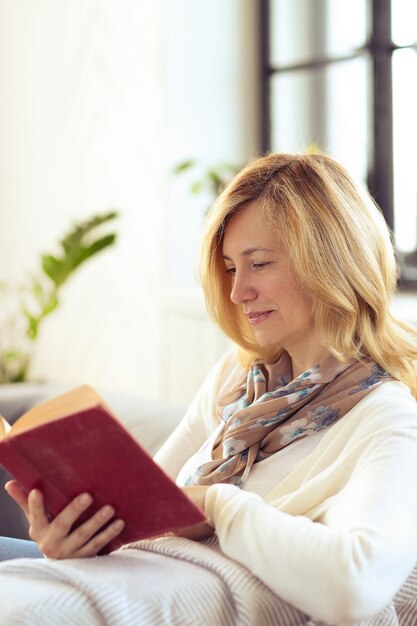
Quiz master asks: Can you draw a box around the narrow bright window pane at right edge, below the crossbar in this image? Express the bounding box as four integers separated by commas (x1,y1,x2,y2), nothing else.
392,49,417,252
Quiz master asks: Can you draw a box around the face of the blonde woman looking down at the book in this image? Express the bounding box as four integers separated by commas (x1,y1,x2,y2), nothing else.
223,201,315,355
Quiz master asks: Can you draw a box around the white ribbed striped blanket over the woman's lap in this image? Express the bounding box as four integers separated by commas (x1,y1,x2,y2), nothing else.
0,537,417,626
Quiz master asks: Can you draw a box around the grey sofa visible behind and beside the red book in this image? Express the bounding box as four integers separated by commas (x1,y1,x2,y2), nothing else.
0,383,184,539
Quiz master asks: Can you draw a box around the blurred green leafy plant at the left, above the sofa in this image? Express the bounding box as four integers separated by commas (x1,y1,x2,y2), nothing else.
0,211,118,383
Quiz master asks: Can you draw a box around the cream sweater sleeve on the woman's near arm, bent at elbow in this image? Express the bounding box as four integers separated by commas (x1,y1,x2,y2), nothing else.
205,404,417,624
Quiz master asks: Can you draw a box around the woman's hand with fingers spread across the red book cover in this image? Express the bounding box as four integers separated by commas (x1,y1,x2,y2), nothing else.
5,480,124,559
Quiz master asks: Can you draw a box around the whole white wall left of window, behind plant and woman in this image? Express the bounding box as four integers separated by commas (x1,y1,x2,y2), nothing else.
0,0,257,403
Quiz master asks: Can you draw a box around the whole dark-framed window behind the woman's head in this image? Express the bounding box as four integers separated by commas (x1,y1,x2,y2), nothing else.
261,0,417,288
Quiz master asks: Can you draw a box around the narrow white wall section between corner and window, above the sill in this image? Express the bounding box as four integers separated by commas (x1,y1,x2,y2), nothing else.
164,0,260,286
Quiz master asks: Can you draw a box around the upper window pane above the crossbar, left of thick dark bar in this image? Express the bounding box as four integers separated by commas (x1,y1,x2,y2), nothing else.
270,0,367,66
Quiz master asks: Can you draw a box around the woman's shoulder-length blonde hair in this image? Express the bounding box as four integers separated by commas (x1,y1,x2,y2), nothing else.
200,153,417,397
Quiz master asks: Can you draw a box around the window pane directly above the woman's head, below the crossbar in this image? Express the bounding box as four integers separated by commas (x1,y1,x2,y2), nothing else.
271,57,368,181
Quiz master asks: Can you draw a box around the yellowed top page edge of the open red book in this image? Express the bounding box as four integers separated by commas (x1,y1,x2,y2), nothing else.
9,385,112,436
